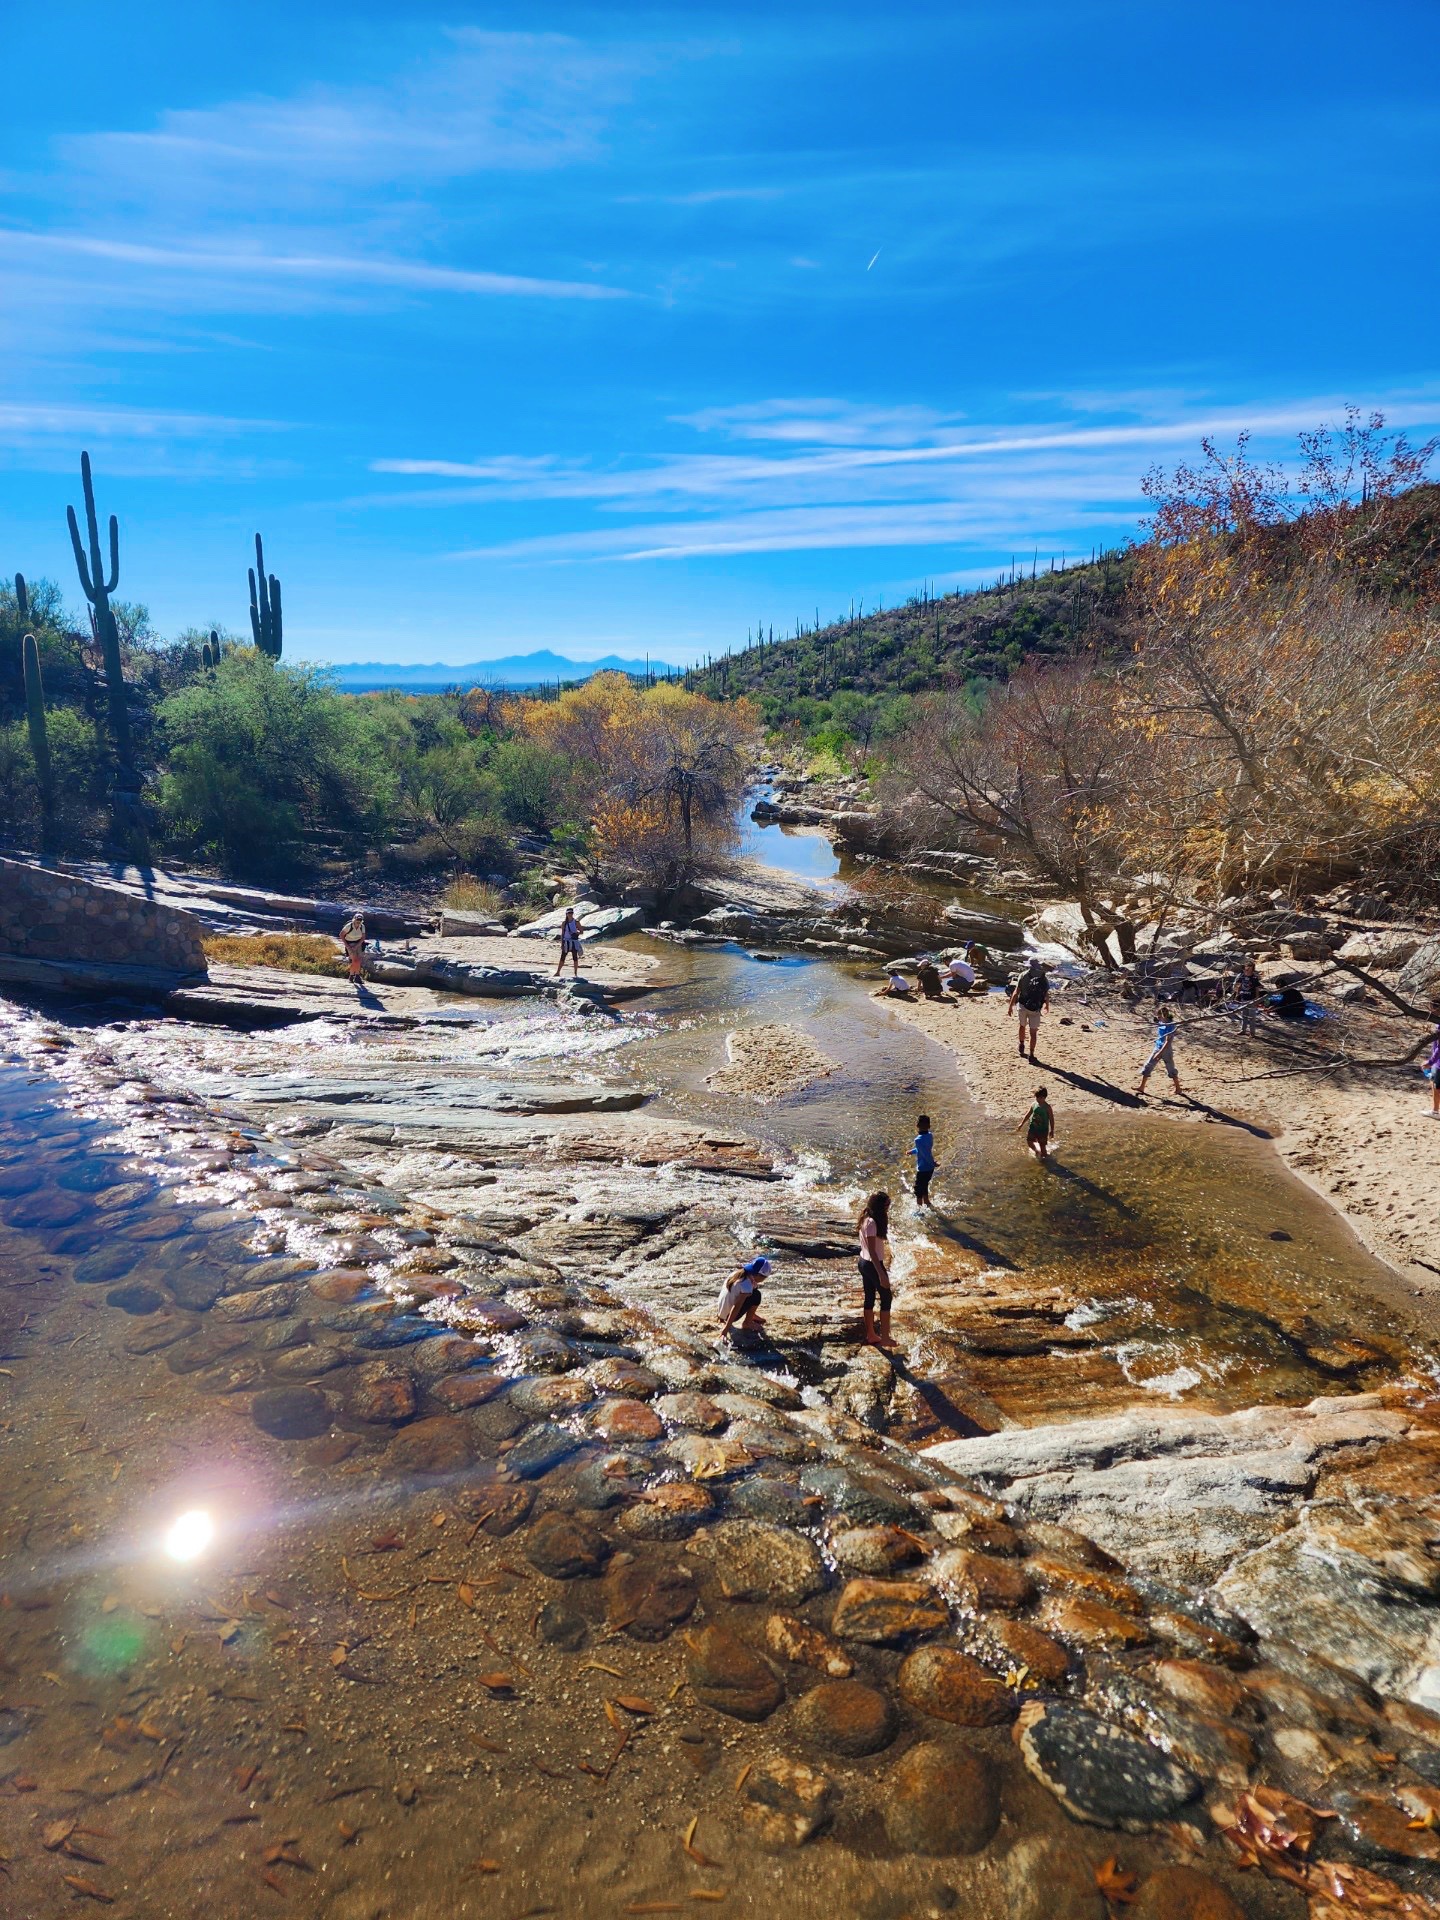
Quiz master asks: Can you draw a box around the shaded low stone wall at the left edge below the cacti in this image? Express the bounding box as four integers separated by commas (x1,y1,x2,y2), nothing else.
0,860,205,975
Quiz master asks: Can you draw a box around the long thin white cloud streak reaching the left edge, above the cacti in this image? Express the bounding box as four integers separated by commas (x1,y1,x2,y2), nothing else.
0,227,628,300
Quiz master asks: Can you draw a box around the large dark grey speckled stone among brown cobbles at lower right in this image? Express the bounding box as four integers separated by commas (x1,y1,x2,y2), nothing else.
1020,1703,1200,1834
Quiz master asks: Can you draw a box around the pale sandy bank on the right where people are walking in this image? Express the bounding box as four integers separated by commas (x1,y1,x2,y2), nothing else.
889,989,1440,1308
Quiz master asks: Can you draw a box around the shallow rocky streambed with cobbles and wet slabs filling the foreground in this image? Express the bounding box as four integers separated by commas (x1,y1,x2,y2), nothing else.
0,956,1440,1920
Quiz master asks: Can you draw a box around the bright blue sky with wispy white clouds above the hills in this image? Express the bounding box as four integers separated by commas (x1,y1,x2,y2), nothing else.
0,0,1440,662
